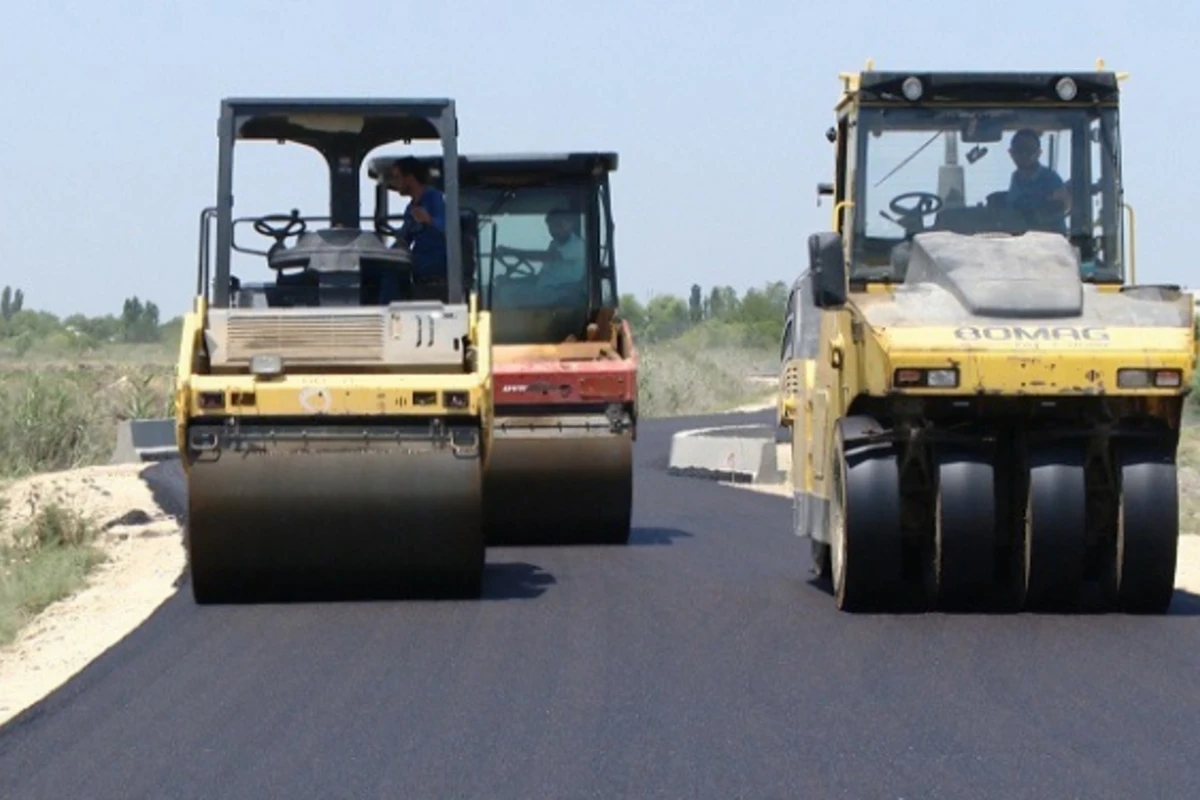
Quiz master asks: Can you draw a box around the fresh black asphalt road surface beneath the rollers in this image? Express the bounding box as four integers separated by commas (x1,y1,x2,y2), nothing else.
0,415,1200,800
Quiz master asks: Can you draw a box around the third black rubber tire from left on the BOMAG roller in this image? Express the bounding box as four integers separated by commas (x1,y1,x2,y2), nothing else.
1016,445,1087,610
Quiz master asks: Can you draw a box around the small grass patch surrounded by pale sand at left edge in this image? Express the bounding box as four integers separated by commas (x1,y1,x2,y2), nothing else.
0,505,104,645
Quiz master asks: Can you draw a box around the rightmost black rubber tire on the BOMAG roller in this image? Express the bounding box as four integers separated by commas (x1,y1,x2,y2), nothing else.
1105,444,1180,614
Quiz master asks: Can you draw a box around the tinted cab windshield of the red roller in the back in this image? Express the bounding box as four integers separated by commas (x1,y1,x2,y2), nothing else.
460,186,592,309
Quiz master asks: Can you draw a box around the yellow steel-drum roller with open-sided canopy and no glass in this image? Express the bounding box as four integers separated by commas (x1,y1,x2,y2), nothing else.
176,100,491,603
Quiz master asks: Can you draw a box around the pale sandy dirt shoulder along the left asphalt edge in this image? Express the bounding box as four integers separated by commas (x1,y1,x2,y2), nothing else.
0,464,186,724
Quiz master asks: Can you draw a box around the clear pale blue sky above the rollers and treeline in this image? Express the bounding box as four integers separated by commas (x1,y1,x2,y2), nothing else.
0,0,1200,318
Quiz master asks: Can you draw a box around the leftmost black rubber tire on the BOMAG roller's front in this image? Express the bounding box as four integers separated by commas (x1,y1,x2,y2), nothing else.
829,435,904,612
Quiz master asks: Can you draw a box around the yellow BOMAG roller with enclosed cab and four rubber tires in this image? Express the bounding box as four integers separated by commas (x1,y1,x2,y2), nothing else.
780,66,1196,613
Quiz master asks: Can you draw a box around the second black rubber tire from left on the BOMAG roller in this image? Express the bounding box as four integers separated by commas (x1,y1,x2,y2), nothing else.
928,450,996,610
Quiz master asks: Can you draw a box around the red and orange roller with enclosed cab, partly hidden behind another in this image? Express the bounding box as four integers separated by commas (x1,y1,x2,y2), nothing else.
371,152,637,546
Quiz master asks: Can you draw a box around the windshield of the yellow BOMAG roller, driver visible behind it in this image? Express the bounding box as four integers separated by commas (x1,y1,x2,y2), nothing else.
851,108,1123,281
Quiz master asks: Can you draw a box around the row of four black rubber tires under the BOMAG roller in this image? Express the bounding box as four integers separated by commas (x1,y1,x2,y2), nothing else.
812,424,1178,614
